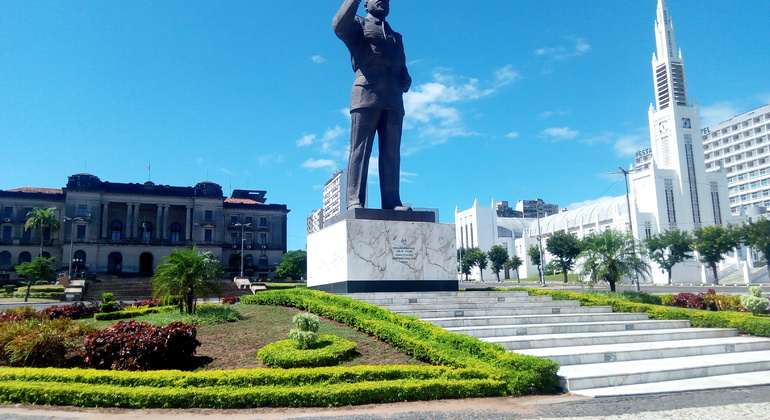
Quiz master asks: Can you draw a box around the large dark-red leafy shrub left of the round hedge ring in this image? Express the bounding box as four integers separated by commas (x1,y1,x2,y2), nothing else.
83,321,200,370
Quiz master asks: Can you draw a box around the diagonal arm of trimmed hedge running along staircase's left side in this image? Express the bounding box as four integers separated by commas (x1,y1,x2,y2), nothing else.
241,289,559,396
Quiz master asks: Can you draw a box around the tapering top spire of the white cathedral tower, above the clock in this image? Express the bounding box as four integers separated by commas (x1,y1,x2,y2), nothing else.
652,0,688,110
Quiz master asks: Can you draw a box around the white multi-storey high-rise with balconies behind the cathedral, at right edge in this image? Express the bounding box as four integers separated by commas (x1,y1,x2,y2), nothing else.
701,105,770,216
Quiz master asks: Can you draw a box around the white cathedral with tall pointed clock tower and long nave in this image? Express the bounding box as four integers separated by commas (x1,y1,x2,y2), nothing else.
455,0,740,283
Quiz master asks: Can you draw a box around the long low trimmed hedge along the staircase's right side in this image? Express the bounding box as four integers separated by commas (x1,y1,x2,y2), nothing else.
494,287,770,337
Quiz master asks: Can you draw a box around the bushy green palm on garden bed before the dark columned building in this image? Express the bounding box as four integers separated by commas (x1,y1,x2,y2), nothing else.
152,246,222,314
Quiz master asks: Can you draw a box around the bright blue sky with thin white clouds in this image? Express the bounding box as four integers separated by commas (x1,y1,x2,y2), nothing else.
0,0,770,249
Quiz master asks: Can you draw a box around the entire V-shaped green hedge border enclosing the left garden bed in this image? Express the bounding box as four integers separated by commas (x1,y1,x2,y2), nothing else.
0,289,558,408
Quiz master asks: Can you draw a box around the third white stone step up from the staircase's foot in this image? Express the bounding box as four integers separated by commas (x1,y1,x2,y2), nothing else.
516,336,770,366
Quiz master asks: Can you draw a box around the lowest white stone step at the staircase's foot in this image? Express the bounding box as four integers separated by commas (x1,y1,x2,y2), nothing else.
571,370,770,398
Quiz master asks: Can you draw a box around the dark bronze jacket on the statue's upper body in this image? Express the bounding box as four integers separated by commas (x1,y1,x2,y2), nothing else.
332,0,412,112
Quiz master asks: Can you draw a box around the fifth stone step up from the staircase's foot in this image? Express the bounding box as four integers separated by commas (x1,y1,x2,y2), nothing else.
446,320,690,338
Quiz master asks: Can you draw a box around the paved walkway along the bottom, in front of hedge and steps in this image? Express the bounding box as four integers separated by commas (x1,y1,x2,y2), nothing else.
0,386,770,420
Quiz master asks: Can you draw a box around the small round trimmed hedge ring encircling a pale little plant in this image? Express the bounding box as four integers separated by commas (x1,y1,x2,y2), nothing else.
257,334,357,368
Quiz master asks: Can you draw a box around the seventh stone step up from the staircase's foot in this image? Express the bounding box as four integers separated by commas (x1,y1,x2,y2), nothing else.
396,305,612,321
